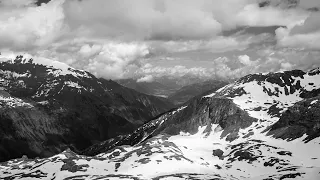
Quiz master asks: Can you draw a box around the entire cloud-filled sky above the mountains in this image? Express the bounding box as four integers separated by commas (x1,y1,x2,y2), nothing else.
0,0,320,82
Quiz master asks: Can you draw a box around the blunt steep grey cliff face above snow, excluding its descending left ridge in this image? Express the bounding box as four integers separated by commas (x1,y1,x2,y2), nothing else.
162,98,256,141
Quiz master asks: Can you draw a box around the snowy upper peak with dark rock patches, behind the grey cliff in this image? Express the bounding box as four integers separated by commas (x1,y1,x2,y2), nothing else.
203,68,320,125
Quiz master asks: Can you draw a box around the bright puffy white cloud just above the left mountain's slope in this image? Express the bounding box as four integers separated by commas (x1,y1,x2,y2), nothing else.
22,41,150,79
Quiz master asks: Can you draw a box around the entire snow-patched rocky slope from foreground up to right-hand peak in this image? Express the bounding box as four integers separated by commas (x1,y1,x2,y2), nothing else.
0,69,320,180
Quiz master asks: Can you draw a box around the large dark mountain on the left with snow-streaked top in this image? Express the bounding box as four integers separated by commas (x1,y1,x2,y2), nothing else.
0,56,173,161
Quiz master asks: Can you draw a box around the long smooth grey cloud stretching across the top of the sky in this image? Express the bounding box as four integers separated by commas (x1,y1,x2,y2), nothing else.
60,0,306,41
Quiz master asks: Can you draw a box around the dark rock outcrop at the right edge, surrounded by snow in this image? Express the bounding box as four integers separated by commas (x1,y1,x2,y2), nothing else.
268,96,320,142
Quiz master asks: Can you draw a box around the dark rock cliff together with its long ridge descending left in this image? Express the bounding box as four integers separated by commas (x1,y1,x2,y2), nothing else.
81,95,256,155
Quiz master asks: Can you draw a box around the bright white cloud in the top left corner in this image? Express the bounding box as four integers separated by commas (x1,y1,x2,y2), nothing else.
0,0,64,50
